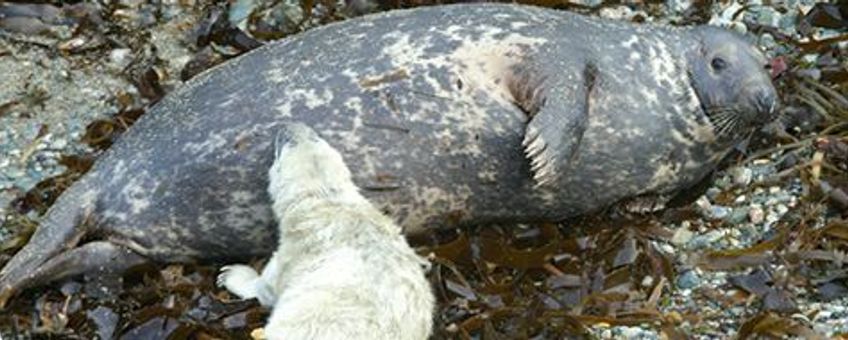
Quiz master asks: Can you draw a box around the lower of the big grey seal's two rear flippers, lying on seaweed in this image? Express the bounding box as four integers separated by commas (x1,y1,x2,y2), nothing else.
0,241,146,306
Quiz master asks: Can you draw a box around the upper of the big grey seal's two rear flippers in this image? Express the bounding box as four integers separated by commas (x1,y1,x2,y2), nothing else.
0,182,93,309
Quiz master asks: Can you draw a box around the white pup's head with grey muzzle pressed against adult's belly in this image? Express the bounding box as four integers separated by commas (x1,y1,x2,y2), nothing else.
268,123,358,211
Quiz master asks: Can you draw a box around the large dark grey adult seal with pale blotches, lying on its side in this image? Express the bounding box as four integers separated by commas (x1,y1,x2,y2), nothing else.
0,4,777,303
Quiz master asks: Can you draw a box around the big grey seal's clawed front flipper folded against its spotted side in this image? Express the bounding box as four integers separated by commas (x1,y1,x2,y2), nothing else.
510,61,597,186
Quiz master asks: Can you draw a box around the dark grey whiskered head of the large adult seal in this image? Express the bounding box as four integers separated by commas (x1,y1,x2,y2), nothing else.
687,26,778,140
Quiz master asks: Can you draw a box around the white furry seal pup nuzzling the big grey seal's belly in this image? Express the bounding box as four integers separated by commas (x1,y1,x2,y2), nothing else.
218,124,434,339
